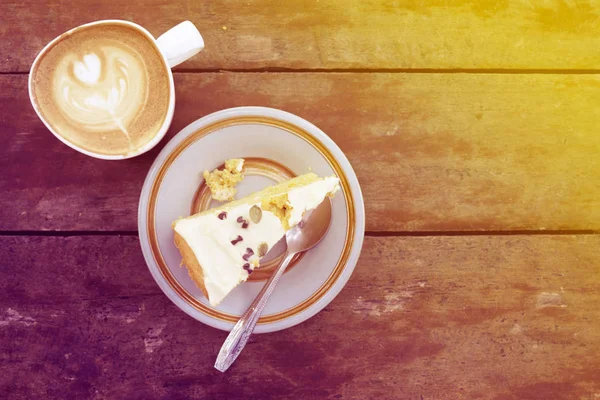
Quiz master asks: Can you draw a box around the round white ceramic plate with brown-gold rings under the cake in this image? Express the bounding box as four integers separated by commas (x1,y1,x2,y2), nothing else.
138,107,365,333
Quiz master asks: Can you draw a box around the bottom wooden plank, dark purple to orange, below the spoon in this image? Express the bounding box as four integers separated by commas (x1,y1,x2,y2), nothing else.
0,236,600,399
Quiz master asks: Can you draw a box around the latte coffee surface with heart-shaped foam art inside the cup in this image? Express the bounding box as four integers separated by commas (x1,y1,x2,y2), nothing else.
32,22,170,155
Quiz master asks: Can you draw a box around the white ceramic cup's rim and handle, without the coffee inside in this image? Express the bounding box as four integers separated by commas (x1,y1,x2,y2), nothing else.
29,20,204,160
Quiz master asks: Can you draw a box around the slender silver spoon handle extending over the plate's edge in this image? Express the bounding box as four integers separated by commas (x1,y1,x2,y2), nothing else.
215,253,296,372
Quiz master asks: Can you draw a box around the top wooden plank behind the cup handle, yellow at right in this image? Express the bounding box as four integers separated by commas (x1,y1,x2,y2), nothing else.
0,0,600,72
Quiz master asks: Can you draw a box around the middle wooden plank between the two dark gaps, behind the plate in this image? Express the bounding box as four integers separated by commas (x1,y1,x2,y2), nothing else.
0,73,600,231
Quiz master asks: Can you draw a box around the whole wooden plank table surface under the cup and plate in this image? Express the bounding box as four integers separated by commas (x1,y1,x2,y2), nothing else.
0,0,600,400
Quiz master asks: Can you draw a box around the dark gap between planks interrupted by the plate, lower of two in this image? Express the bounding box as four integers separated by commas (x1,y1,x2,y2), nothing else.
0,230,600,237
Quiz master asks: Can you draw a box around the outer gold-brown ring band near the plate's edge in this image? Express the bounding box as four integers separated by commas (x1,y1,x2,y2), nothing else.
147,116,356,324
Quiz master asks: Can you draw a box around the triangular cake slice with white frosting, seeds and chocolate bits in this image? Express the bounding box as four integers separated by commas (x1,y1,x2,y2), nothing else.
173,173,339,306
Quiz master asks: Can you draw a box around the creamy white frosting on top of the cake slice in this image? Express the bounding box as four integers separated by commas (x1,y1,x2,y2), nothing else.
174,177,339,306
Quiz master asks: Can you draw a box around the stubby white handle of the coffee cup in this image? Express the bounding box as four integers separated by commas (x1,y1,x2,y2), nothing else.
156,21,204,68
